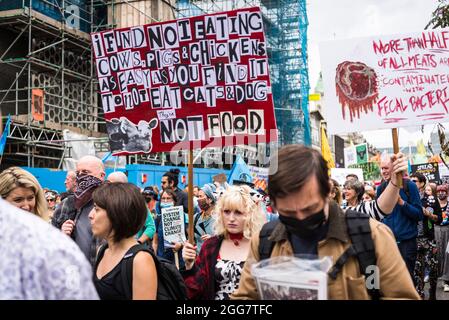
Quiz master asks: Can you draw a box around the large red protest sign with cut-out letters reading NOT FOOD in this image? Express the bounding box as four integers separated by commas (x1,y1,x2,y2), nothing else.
91,8,277,154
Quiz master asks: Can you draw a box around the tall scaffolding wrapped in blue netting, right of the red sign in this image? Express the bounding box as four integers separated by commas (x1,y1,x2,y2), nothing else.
178,0,311,145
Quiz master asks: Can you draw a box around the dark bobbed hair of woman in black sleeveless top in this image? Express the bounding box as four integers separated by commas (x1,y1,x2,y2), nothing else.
92,182,147,242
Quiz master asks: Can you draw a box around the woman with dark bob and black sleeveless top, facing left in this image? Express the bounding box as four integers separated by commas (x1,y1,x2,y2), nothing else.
89,182,158,300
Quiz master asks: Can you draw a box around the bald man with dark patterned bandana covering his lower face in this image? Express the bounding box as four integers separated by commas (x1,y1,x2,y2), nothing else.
61,156,106,266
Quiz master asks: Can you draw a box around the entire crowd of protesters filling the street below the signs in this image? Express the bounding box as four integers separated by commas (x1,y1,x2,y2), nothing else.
0,139,449,300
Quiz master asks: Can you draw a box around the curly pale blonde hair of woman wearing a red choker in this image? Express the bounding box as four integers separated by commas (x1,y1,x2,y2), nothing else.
214,185,265,239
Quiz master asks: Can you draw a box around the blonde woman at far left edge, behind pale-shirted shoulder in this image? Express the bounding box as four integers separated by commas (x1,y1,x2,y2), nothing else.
0,167,48,220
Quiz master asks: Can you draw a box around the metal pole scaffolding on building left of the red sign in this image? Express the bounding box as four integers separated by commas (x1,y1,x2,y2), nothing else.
0,0,175,169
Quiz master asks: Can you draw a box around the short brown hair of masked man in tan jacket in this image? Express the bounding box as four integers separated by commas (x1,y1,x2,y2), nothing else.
268,144,330,204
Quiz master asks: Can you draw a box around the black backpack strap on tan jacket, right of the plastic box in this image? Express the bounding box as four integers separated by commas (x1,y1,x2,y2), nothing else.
346,210,381,300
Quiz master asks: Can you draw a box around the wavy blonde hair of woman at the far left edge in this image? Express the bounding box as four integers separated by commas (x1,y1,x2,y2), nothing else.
0,167,48,220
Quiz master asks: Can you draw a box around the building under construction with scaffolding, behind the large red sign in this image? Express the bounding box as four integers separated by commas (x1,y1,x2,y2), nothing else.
0,0,310,169
